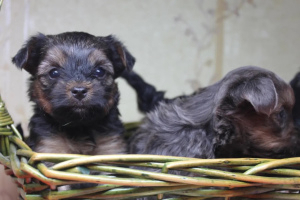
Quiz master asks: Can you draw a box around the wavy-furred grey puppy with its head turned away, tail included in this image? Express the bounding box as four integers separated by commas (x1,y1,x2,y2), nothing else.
123,66,299,158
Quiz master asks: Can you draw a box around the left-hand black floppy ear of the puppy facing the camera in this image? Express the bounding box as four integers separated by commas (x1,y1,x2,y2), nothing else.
12,33,47,75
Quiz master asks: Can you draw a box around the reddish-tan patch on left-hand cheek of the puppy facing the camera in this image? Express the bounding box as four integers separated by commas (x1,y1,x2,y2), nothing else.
33,81,52,114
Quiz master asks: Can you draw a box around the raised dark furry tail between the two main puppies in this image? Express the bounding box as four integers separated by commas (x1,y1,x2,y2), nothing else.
121,71,167,113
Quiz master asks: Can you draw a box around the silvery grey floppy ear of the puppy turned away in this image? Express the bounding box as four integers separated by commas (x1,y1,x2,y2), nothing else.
240,77,278,116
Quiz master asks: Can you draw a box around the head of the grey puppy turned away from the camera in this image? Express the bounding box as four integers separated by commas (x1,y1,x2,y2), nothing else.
219,67,300,158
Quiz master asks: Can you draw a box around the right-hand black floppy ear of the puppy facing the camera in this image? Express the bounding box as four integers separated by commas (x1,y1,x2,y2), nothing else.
102,35,135,78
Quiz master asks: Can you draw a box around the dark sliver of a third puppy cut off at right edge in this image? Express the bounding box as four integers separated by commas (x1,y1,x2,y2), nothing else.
290,72,300,129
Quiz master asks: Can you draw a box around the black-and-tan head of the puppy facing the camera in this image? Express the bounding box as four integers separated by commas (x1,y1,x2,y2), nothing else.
12,32,135,123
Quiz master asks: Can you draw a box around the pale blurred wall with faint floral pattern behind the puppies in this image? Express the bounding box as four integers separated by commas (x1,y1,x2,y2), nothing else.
0,0,300,200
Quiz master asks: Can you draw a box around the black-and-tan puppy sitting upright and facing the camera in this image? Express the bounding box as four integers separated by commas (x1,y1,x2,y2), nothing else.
12,32,135,155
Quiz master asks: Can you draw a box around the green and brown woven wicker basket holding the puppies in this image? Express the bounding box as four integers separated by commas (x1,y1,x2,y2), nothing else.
0,95,300,200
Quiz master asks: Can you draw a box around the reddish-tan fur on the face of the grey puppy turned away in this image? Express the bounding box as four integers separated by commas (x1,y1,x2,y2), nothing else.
236,85,295,154
